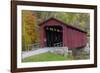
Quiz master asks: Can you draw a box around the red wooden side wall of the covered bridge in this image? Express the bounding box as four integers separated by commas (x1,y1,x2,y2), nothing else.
65,27,87,48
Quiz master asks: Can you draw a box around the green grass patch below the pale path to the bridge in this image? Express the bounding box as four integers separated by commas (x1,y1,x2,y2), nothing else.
22,52,73,62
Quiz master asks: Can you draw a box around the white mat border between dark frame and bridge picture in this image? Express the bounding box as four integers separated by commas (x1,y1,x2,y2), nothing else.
17,5,94,68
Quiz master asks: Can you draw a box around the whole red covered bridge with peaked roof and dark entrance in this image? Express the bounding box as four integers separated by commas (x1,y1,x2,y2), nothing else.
40,18,87,48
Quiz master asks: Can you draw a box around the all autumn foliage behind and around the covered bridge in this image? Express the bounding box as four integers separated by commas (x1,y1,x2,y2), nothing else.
22,10,90,50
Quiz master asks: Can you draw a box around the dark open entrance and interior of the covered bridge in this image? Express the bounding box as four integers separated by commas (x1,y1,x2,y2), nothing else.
45,26,63,47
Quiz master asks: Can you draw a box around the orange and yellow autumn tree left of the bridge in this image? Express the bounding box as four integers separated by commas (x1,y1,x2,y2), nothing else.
22,10,38,50
